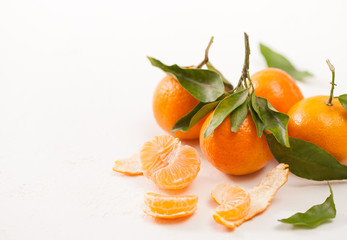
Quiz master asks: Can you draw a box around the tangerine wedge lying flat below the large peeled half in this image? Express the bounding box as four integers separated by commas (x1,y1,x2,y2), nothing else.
144,192,198,219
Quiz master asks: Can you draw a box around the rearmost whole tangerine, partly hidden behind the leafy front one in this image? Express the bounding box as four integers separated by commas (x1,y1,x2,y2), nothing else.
251,68,304,113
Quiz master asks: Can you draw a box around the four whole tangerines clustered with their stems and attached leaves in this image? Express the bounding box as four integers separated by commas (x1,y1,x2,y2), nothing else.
149,34,347,175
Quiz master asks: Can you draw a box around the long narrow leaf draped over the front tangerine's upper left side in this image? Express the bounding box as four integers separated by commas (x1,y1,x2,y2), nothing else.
204,89,248,138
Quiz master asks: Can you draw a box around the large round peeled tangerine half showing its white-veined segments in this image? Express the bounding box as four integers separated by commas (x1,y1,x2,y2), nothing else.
140,135,200,189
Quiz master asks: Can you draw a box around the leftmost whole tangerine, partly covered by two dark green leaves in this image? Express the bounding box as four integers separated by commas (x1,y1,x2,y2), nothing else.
153,75,204,139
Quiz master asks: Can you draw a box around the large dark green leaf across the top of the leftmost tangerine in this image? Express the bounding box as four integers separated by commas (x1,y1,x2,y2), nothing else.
148,57,224,102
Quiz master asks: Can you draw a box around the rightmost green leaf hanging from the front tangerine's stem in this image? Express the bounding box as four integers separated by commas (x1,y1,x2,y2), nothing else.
256,97,290,147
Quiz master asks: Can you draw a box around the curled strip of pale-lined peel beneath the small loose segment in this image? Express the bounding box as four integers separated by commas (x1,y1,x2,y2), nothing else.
211,163,289,229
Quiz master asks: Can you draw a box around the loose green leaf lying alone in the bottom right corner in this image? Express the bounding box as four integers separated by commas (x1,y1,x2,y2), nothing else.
278,183,336,228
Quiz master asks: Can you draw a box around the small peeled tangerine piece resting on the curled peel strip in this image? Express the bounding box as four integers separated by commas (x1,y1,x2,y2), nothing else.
216,185,251,221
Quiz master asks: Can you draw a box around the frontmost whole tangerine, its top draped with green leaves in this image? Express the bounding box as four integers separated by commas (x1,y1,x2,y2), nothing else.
200,113,273,175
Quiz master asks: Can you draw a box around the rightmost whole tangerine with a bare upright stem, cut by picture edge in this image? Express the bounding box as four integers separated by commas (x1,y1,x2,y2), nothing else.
288,96,347,164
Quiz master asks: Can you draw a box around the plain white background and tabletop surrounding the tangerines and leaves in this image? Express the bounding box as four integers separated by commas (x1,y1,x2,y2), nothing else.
0,0,347,240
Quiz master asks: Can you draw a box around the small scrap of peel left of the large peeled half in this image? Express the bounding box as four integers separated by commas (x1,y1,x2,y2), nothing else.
113,153,142,175
